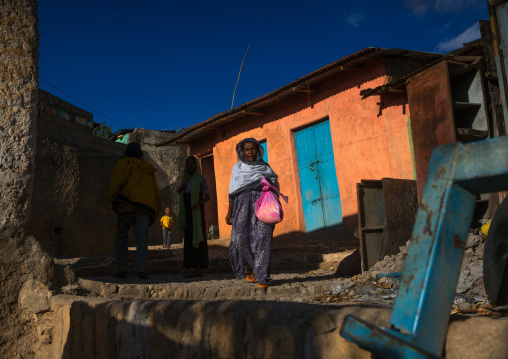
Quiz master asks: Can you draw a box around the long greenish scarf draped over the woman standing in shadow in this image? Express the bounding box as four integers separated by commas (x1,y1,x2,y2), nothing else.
178,156,205,248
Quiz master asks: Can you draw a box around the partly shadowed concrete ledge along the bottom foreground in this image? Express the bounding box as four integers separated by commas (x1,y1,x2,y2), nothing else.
46,295,508,359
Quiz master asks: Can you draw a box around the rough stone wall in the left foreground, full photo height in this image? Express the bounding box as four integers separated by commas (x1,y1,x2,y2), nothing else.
0,0,54,358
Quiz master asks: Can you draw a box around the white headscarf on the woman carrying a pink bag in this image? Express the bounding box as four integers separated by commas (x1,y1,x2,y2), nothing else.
229,138,278,200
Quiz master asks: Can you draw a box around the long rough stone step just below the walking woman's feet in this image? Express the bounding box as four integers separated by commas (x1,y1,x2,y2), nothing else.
78,271,336,302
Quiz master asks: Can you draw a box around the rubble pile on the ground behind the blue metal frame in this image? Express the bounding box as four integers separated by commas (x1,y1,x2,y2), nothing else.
314,232,500,316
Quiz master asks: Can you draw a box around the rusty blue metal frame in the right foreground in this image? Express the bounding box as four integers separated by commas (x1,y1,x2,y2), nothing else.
341,136,508,358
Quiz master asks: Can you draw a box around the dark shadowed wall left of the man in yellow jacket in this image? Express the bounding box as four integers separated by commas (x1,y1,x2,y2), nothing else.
31,90,126,258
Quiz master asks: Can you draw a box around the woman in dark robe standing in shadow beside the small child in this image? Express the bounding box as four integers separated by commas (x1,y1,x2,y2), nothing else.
178,156,210,278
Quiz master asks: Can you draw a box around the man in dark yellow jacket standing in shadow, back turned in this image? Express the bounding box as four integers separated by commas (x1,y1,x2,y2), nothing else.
109,142,161,279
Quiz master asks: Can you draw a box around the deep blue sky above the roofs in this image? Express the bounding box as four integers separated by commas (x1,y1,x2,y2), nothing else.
38,0,488,131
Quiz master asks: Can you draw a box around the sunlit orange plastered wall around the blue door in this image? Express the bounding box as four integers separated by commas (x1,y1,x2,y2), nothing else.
196,60,413,238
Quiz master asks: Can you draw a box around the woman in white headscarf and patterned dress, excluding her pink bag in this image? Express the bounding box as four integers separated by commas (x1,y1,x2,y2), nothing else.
226,138,278,288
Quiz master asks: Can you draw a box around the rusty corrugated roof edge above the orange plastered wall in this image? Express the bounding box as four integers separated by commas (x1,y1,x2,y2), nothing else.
157,47,443,146
